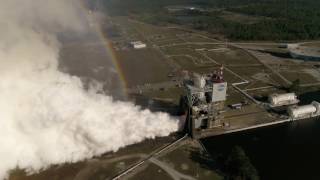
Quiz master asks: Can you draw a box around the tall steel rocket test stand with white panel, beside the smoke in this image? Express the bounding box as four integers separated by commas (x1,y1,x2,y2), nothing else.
184,67,227,136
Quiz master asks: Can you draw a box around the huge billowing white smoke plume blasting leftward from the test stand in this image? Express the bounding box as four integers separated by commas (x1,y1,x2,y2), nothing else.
0,0,178,179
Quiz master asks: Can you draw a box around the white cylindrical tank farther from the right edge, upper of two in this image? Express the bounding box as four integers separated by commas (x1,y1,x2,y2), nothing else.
269,93,299,107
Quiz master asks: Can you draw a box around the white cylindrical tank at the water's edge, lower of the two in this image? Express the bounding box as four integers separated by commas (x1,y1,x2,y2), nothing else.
288,105,317,118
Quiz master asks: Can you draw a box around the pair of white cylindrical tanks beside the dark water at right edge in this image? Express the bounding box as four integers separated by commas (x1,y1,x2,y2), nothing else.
269,93,320,119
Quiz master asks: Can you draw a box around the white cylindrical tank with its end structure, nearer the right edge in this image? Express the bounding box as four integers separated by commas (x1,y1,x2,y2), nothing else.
288,101,320,119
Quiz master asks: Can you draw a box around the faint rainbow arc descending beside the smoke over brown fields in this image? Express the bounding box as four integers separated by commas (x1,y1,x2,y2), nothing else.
80,0,128,97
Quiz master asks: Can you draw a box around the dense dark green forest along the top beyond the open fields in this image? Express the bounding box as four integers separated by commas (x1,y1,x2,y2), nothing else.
100,0,320,41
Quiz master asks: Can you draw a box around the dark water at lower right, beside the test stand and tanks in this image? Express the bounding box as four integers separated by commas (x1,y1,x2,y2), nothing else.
202,92,320,180
